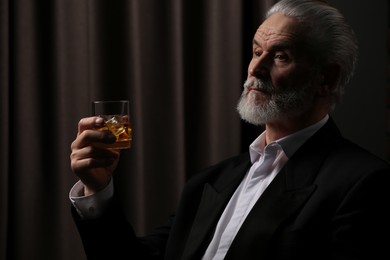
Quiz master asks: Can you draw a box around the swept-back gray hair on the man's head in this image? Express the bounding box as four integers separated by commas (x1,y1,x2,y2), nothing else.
266,0,358,106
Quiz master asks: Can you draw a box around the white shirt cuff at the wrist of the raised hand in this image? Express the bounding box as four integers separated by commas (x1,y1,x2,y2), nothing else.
69,178,114,219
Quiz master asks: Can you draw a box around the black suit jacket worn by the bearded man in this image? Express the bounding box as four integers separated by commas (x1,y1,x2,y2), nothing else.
73,119,390,260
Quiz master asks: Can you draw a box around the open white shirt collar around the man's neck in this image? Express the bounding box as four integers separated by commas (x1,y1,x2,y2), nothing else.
249,114,329,163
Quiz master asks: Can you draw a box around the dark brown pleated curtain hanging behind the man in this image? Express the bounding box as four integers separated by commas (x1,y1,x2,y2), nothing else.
0,0,275,260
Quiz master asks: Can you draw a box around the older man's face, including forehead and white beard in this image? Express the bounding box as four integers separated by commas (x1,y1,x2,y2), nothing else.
238,13,317,125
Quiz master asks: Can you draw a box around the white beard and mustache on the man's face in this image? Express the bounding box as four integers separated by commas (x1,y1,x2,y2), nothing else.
237,77,315,125
